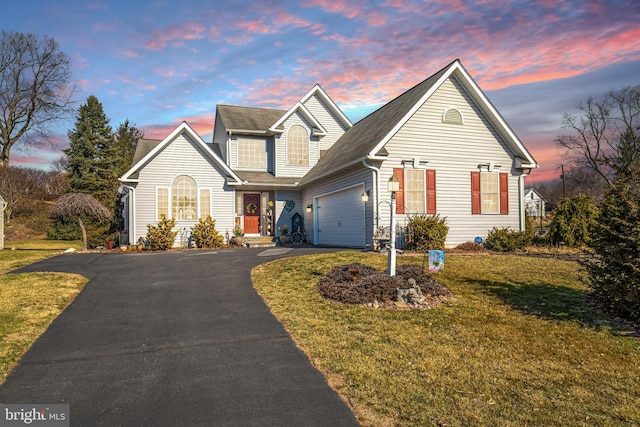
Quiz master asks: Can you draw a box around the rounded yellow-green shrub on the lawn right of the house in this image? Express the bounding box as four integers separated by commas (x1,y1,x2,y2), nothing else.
549,194,598,247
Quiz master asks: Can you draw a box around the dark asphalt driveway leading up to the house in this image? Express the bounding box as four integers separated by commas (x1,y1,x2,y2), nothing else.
0,248,358,426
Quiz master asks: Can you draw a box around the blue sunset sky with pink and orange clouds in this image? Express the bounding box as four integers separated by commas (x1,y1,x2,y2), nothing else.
0,0,640,183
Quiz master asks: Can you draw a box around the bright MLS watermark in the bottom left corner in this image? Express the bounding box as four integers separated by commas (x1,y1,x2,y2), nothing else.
0,403,69,427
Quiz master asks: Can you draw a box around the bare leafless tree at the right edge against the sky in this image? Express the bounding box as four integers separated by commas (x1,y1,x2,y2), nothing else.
556,85,640,186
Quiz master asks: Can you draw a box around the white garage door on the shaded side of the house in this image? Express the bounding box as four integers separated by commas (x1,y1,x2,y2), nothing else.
317,187,365,248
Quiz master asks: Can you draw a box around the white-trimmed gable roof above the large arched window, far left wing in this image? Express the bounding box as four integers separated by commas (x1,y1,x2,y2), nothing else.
119,122,241,183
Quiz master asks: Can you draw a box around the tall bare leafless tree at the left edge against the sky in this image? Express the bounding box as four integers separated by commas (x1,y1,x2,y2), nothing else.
0,31,75,167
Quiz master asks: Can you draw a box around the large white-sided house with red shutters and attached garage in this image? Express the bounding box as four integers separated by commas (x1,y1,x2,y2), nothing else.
121,60,538,247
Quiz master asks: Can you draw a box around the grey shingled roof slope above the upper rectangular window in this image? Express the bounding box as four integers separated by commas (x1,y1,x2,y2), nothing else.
216,105,287,135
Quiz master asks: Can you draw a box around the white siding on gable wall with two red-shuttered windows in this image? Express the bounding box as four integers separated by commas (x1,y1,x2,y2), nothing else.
380,76,520,246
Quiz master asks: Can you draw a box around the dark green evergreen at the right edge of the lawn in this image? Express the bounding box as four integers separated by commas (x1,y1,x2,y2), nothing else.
584,181,640,322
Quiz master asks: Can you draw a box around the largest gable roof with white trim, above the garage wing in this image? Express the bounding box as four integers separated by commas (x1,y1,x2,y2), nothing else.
302,59,538,184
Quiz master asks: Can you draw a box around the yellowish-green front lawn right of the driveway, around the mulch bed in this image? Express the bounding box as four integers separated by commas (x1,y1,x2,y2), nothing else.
252,251,640,426
